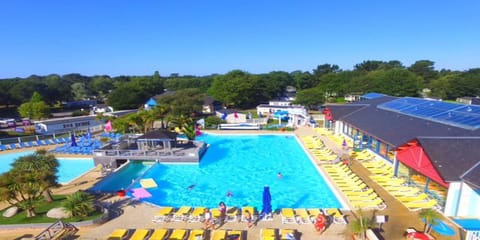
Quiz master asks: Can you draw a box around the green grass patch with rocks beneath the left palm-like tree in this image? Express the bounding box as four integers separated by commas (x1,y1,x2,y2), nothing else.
0,195,102,225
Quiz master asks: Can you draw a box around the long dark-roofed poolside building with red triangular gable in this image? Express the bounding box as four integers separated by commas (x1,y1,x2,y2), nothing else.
325,93,480,232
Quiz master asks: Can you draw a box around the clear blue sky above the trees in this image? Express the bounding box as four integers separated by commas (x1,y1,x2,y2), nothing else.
0,0,480,78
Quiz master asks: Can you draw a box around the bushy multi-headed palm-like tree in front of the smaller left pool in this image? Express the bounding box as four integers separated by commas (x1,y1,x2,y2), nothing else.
0,151,59,217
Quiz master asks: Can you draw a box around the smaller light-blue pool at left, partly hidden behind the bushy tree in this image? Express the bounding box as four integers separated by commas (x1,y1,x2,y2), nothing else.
0,151,94,183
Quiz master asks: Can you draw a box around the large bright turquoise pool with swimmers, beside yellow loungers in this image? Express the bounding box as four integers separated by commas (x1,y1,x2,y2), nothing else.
91,134,342,209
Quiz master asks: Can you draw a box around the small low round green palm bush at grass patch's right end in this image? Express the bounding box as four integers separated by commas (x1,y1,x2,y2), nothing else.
62,191,95,217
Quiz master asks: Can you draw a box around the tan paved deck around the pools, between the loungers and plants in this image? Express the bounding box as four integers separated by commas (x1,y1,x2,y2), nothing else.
0,127,460,240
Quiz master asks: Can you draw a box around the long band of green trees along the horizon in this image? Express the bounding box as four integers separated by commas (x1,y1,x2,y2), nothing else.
0,60,480,110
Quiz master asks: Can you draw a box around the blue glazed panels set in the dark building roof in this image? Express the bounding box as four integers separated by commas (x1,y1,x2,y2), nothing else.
378,97,480,129
